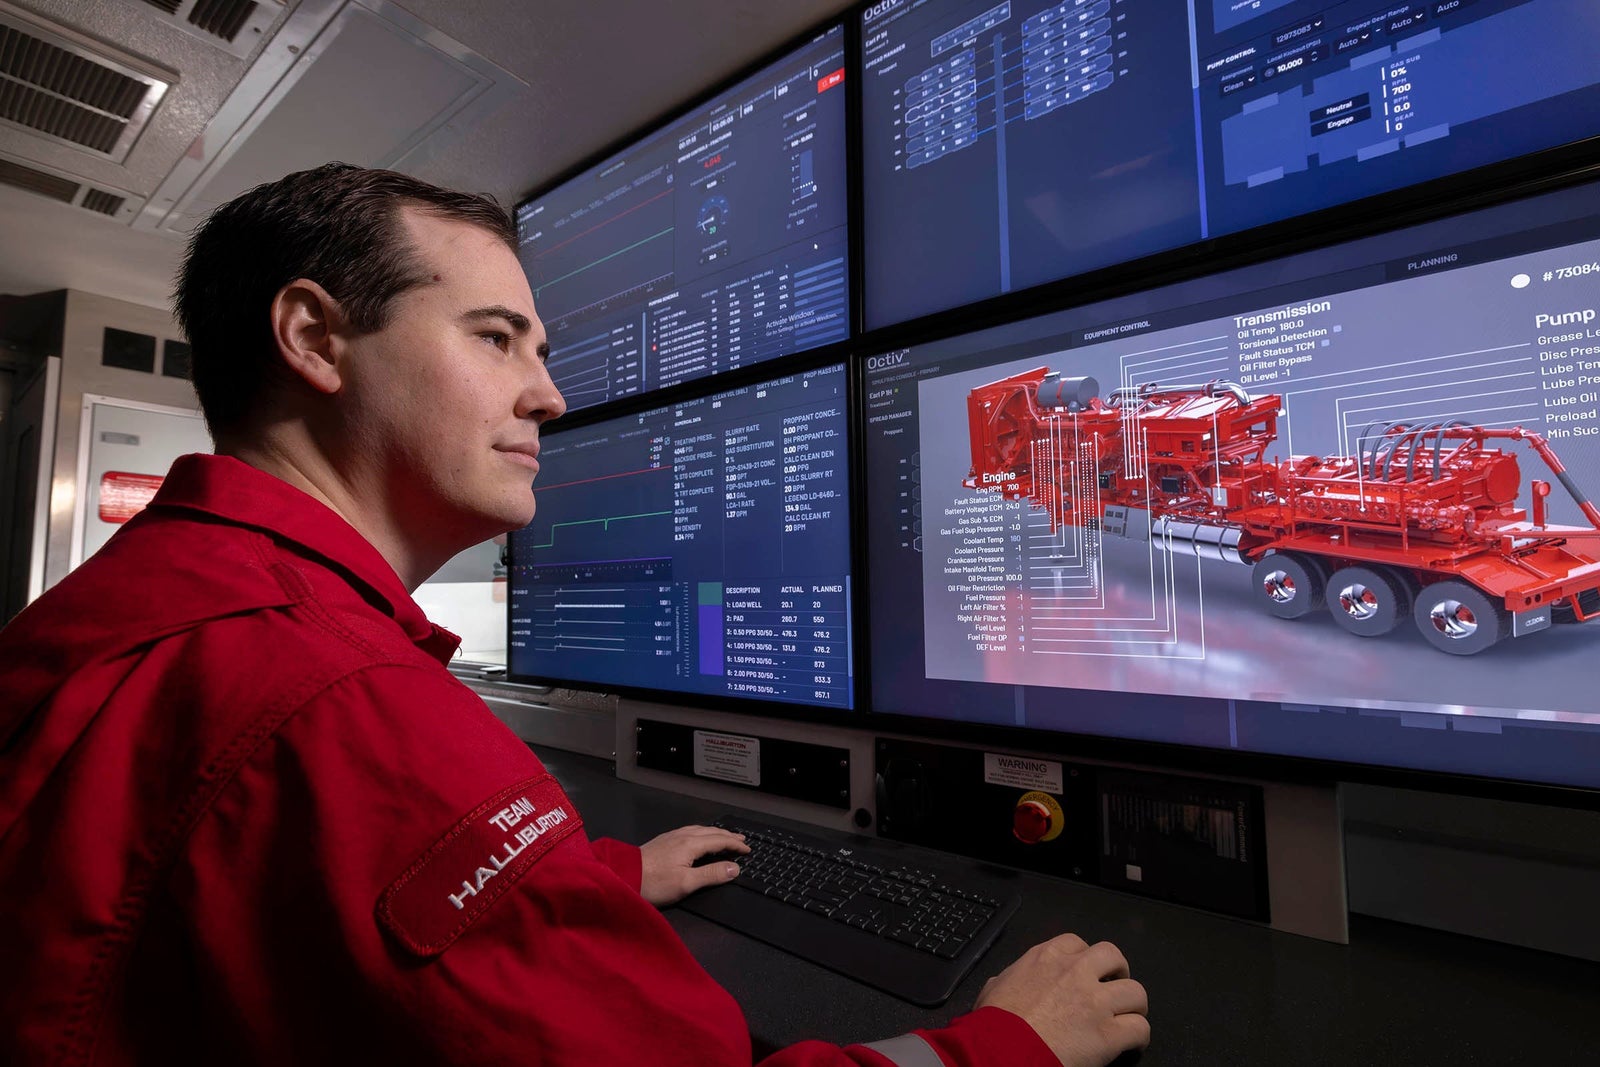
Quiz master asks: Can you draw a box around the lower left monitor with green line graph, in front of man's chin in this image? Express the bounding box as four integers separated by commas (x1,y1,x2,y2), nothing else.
507,365,853,709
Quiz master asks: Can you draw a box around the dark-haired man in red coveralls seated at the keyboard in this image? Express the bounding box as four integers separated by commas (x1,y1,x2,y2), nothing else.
0,165,1149,1067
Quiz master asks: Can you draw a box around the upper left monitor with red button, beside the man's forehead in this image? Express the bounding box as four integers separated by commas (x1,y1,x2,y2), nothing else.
517,26,850,410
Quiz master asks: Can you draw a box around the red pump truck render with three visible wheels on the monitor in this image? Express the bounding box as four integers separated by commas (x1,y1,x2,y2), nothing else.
965,368,1600,656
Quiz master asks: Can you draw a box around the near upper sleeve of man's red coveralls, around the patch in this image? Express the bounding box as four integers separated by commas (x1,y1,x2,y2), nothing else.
170,667,752,1067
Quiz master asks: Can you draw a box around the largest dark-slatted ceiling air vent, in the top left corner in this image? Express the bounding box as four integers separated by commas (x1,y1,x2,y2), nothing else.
0,5,173,163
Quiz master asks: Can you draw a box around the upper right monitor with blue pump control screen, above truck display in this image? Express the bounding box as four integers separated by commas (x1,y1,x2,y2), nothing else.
862,0,1600,328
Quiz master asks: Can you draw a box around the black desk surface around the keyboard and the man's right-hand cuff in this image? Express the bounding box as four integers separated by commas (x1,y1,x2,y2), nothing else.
539,750,1600,1067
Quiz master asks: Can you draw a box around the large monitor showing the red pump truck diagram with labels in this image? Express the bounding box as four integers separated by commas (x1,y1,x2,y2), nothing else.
861,177,1600,787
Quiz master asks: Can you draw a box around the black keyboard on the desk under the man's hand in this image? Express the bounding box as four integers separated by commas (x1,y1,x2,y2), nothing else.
680,816,1019,1008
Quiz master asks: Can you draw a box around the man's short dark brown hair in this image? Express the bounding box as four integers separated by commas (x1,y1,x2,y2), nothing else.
173,163,517,438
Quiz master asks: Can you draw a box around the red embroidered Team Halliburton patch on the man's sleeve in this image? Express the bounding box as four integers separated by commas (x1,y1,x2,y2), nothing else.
378,774,584,957
